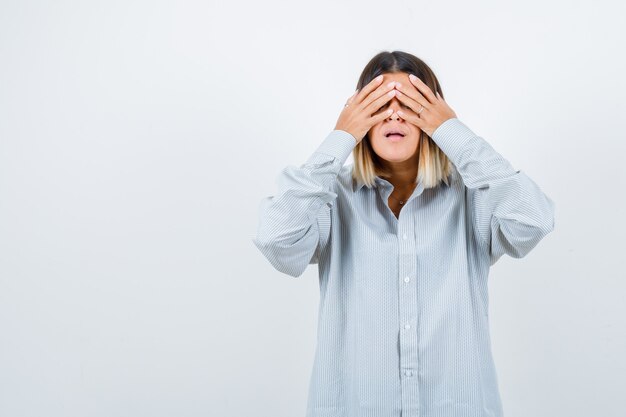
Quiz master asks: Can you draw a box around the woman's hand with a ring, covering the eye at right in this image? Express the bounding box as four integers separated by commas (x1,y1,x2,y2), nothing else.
394,76,457,137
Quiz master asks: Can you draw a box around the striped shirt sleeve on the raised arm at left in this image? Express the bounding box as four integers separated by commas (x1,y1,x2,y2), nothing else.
252,130,357,277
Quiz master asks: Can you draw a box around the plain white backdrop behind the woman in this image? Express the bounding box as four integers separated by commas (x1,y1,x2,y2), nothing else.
0,0,626,417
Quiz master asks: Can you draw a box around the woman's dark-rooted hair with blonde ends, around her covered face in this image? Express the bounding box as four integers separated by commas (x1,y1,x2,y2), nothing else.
352,51,454,189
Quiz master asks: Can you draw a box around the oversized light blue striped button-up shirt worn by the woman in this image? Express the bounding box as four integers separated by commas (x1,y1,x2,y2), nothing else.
253,117,554,417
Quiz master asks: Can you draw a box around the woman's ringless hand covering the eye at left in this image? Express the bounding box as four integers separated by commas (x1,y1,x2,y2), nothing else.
335,74,396,143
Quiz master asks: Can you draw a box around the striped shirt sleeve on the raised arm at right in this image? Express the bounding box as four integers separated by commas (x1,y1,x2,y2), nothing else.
432,118,554,265
